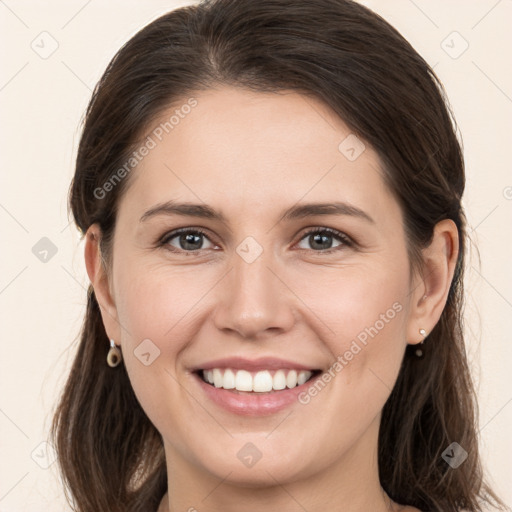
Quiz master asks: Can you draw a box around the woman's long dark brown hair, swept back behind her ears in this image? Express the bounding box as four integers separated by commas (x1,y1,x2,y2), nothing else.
50,0,503,512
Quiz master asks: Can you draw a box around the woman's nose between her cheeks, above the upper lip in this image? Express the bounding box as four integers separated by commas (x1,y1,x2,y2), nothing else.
214,244,296,341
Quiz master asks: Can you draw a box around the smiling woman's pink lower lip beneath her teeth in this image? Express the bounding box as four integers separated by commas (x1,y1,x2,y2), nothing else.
194,373,321,416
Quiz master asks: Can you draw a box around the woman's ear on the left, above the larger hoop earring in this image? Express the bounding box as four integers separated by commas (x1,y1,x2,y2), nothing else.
84,224,121,345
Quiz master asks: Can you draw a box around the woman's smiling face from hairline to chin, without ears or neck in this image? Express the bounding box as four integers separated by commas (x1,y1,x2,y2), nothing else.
95,88,420,485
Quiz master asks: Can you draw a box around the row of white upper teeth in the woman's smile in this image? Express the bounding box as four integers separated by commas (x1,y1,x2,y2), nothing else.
202,368,313,393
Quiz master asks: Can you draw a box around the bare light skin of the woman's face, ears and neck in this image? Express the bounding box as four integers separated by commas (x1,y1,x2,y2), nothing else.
85,87,458,512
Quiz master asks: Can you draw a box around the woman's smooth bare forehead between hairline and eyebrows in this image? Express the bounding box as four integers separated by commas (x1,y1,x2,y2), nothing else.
122,87,397,224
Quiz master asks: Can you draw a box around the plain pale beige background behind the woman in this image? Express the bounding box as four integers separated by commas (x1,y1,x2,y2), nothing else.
0,0,512,512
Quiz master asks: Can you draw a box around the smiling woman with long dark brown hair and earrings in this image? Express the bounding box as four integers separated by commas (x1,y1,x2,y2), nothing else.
52,0,508,512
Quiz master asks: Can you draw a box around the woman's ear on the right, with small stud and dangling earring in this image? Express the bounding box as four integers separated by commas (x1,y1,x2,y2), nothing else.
407,219,459,345
